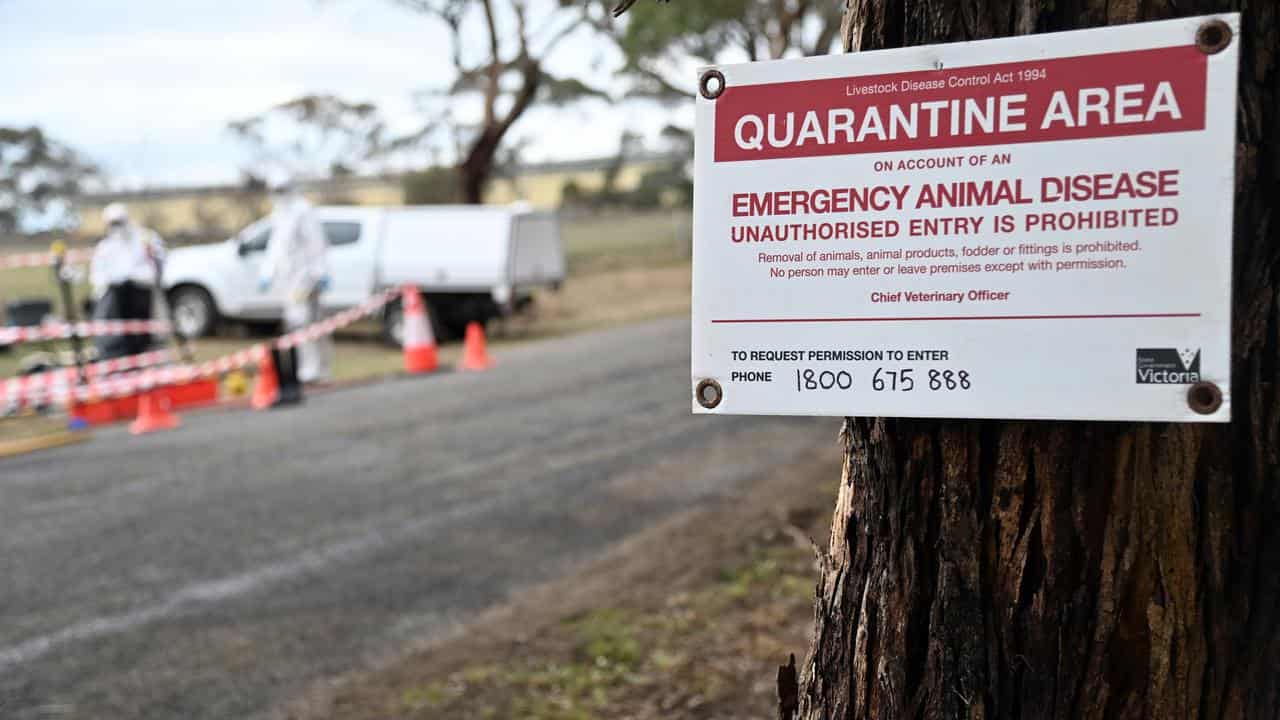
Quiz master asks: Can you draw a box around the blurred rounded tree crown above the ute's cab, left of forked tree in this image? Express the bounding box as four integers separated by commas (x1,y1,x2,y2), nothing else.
227,95,387,178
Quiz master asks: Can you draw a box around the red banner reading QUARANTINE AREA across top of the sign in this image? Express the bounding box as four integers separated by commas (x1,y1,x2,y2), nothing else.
716,45,1208,163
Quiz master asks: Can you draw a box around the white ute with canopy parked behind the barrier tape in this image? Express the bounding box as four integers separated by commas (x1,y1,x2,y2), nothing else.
164,205,564,342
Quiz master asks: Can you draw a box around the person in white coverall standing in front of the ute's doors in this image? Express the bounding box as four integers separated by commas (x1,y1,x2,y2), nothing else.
261,192,333,383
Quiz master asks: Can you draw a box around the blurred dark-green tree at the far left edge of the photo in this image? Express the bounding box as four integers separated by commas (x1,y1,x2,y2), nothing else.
0,126,99,234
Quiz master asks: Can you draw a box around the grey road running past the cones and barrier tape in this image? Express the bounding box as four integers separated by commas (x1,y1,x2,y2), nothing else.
0,320,835,720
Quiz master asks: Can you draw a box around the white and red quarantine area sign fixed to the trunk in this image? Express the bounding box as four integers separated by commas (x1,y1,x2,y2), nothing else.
691,14,1239,421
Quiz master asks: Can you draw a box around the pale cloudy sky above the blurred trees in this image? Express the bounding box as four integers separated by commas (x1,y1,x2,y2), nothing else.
0,0,692,188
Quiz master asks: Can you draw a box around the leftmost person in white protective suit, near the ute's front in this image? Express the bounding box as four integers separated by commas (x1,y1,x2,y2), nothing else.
90,202,164,360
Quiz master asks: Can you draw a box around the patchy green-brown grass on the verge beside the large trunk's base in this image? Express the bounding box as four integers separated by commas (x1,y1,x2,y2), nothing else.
378,543,813,720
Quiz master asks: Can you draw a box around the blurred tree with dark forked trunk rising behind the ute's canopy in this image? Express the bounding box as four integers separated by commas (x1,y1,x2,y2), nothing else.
394,0,609,204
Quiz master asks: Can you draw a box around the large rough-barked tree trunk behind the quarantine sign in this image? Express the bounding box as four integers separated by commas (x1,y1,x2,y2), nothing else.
797,0,1280,720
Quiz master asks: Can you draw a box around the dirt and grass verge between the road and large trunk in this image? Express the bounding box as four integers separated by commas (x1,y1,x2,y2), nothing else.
271,435,840,720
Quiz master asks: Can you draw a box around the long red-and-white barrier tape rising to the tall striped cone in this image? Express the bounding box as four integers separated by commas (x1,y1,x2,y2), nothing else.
0,285,399,405
